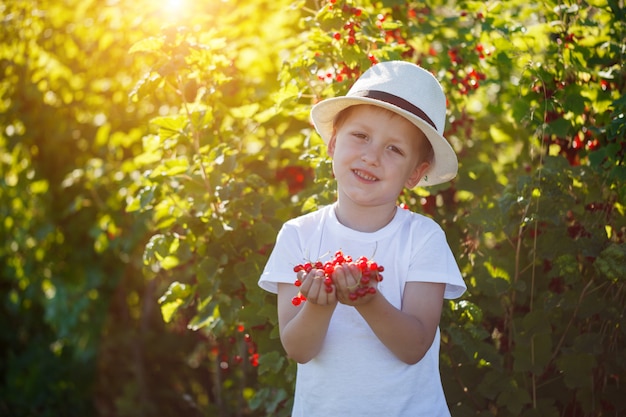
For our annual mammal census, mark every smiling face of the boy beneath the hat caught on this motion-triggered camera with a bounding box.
[328,105,429,205]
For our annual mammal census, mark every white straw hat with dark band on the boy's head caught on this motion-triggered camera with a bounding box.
[311,61,458,186]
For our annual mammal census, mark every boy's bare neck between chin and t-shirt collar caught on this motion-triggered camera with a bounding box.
[335,200,397,233]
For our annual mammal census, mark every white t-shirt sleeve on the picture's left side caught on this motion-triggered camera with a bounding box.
[258,223,304,294]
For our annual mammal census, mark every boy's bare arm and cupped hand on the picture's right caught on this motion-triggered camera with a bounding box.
[335,268,445,364]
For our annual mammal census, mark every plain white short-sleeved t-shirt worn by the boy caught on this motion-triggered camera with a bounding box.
[259,205,466,417]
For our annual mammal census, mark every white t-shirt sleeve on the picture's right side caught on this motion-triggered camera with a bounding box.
[407,227,467,299]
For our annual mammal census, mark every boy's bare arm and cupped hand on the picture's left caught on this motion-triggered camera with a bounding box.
[278,271,337,363]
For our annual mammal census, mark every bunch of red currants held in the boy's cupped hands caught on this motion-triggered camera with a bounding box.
[291,250,385,306]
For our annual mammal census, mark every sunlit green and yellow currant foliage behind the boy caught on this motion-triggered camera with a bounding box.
[0,0,626,417]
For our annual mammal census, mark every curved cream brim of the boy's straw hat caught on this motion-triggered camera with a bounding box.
[311,96,459,187]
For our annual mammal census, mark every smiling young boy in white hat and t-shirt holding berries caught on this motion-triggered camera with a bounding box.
[259,61,466,417]
